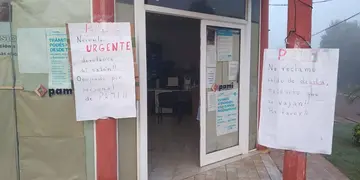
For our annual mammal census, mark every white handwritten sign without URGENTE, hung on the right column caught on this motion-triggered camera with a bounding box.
[258,49,339,154]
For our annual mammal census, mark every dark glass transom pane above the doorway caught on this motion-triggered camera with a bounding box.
[145,0,246,19]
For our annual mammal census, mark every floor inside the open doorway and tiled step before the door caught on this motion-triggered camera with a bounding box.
[149,117,281,180]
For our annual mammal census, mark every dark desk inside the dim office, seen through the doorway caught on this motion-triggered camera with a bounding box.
[148,89,192,114]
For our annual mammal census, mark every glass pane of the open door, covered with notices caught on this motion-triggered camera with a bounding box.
[206,26,241,153]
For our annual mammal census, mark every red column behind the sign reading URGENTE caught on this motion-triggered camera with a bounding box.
[92,0,118,180]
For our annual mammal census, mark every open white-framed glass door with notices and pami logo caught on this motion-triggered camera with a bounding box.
[200,20,249,166]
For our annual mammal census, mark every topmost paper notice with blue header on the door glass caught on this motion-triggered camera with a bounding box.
[216,29,234,61]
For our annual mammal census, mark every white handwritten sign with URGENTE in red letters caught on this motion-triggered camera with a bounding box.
[68,23,136,121]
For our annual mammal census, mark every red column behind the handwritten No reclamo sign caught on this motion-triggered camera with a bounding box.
[283,0,312,180]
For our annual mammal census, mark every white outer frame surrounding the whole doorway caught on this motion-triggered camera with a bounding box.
[134,0,251,180]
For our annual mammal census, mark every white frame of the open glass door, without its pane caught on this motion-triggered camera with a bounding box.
[200,20,250,166]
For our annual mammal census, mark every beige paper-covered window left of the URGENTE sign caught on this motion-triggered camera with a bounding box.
[9,0,90,180]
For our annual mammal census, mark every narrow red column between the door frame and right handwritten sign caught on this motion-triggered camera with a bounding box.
[256,0,269,151]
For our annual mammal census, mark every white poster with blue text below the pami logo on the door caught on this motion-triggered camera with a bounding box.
[216,89,238,136]
